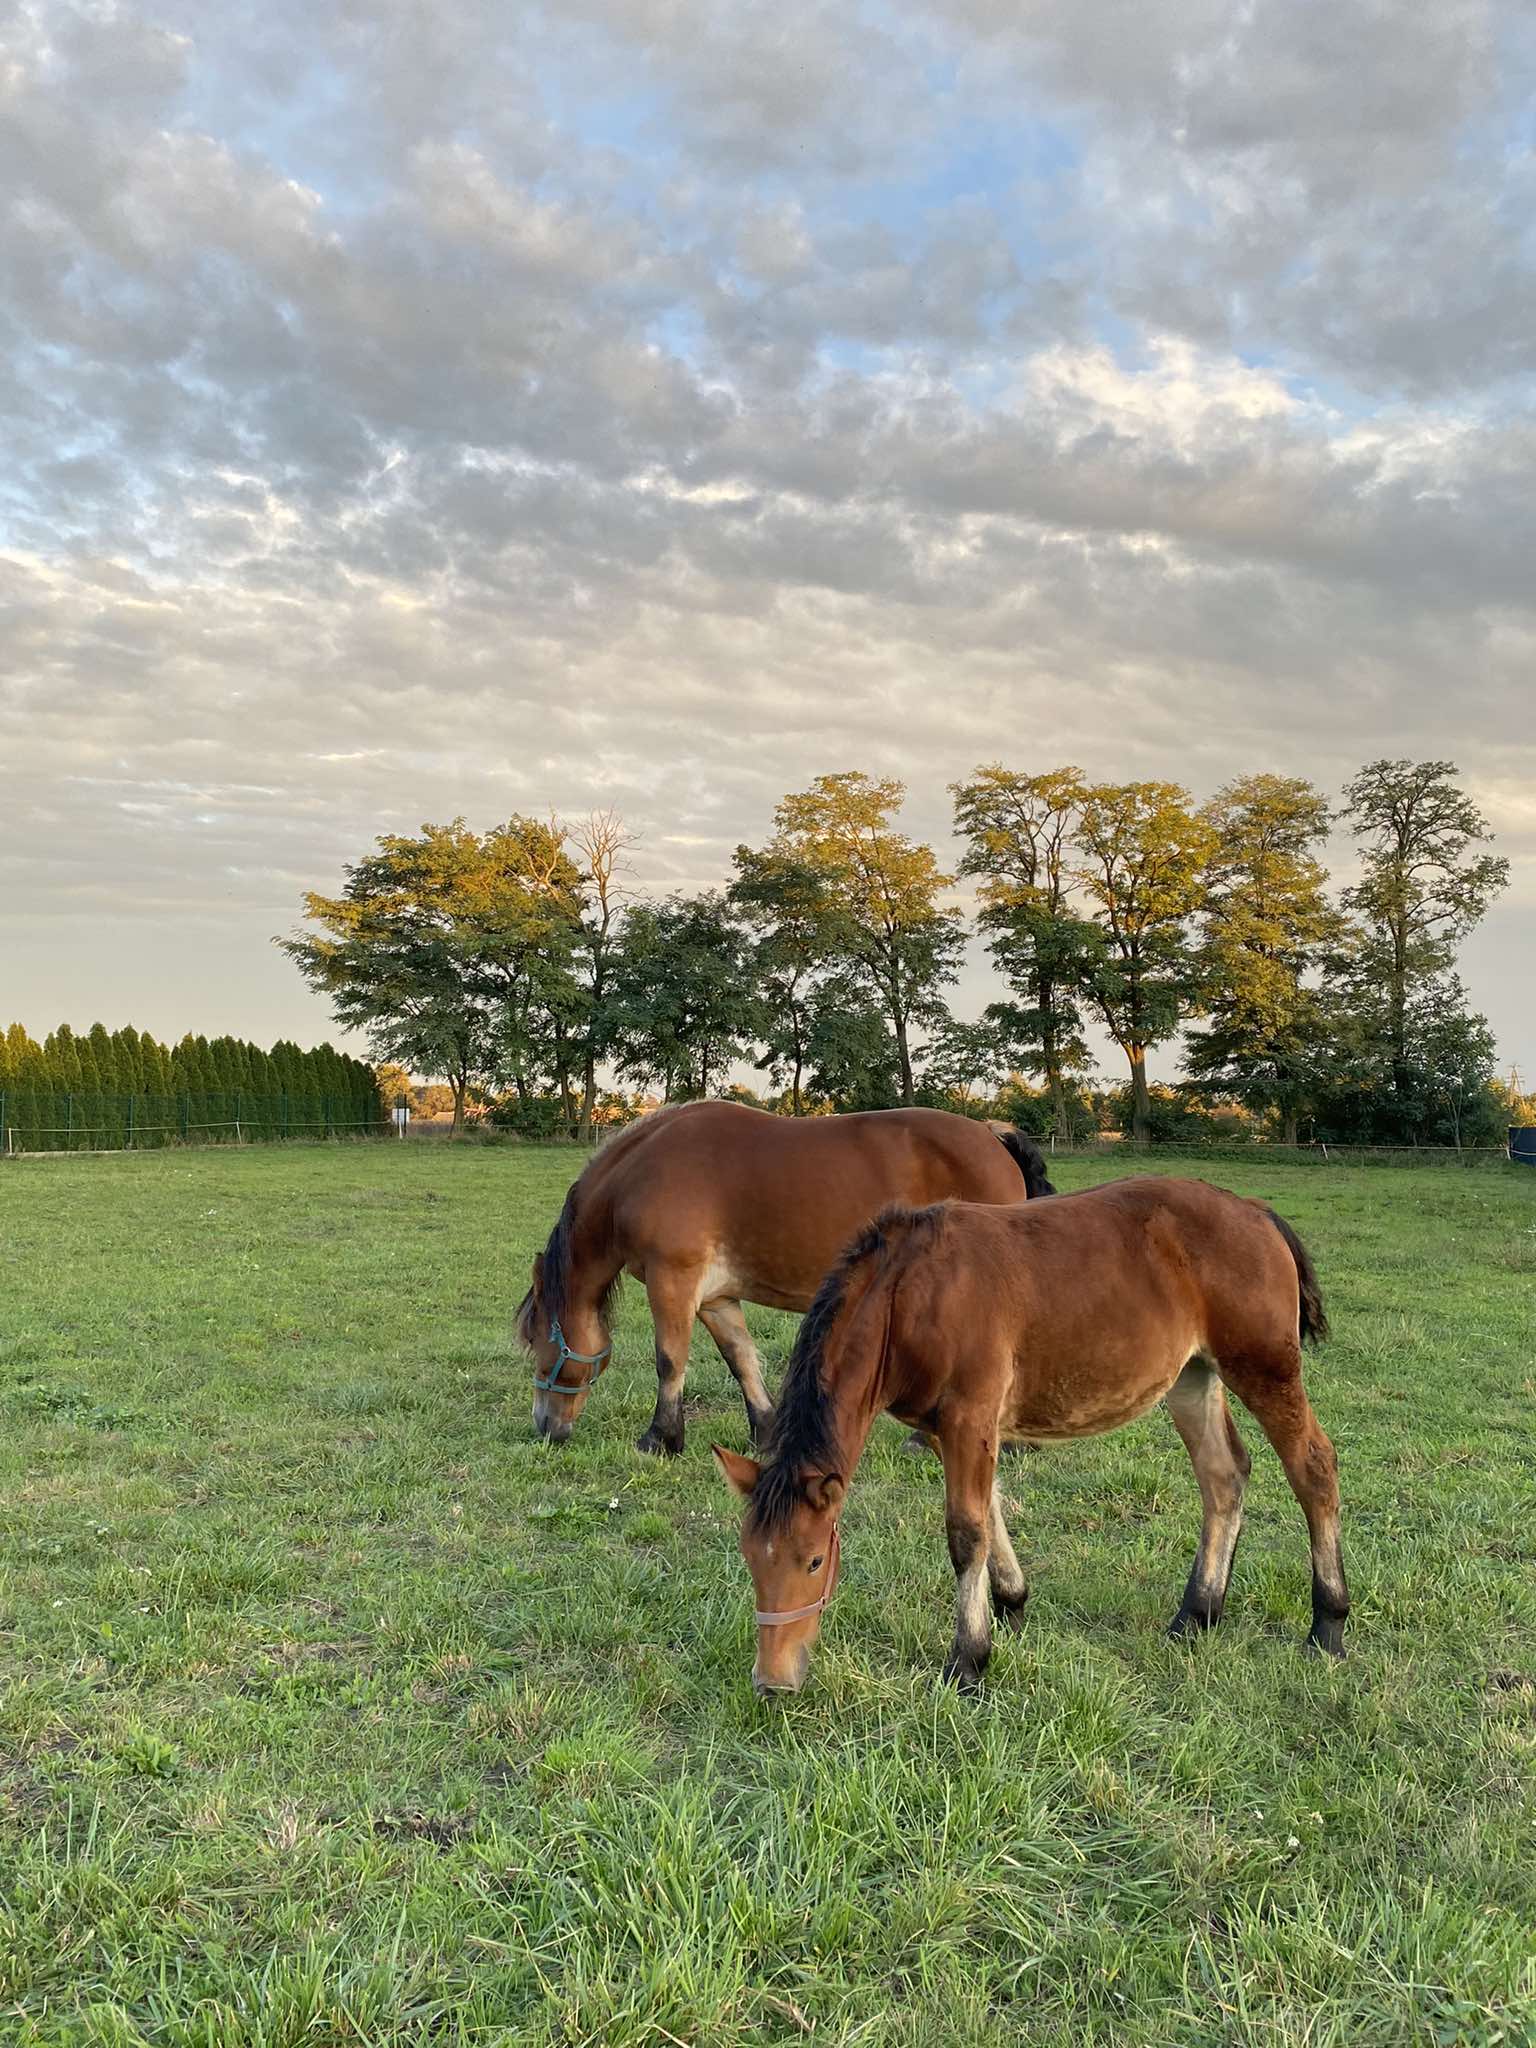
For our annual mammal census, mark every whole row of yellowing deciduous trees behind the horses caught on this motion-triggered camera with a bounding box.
[279,760,1507,1143]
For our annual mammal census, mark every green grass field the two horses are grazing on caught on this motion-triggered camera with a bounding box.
[0,1145,1536,2048]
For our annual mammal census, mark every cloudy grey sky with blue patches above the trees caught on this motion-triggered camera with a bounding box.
[0,0,1536,1079]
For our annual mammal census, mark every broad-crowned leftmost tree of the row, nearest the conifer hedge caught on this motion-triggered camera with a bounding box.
[279,817,580,1128]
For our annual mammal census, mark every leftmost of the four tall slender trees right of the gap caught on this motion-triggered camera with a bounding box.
[950,762,1090,1137]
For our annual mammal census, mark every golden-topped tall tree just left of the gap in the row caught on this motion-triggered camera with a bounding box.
[774,772,965,1102]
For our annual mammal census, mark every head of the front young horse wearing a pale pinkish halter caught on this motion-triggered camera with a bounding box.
[715,1444,848,1692]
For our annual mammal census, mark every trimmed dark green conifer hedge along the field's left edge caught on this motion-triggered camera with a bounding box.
[0,1024,385,1151]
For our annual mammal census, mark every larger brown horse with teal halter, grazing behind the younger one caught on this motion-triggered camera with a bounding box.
[516,1102,1055,1454]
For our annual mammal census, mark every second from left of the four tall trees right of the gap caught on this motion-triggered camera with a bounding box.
[1077,782,1217,1143]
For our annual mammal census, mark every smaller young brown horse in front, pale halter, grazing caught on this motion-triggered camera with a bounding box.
[715,1180,1350,1692]
